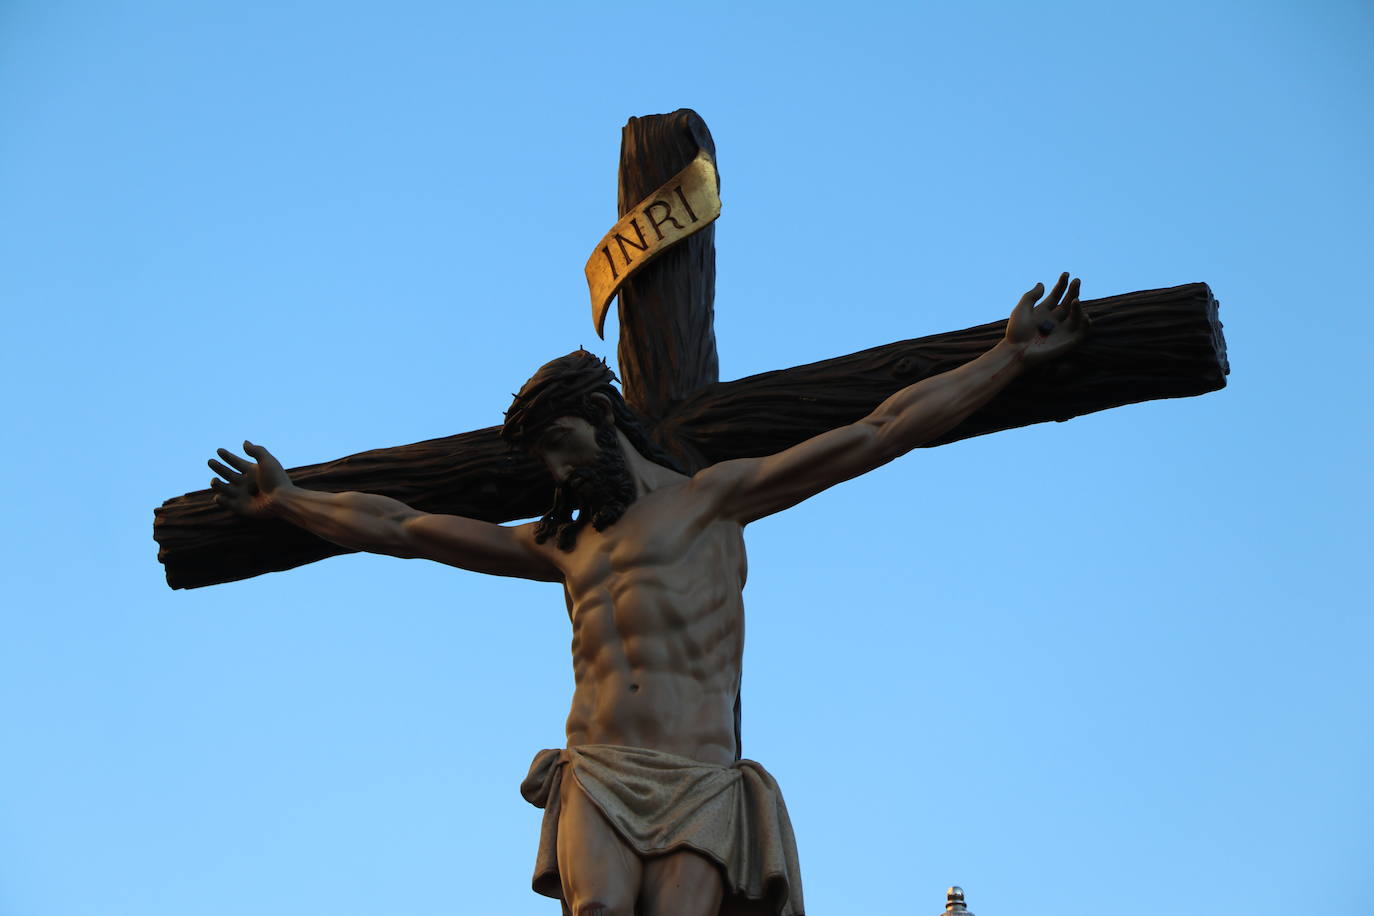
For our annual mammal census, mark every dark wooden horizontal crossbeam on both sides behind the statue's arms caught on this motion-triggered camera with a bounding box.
[154,283,1228,588]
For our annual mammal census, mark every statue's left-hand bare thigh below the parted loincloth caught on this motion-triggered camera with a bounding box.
[558,768,643,916]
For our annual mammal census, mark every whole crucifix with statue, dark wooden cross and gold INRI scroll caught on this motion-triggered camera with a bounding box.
[154,110,1228,916]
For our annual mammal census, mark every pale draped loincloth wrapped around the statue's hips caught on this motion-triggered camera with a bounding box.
[519,744,804,916]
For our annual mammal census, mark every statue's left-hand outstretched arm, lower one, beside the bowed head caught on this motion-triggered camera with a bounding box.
[209,442,562,582]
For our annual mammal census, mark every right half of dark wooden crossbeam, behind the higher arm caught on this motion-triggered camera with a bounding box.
[657,283,1230,464]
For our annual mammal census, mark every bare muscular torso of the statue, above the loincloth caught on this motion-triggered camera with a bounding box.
[544,481,746,765]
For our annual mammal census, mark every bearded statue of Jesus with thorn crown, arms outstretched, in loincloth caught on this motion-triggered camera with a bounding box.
[209,273,1087,916]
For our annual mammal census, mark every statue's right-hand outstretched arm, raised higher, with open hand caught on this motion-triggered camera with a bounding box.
[692,273,1087,523]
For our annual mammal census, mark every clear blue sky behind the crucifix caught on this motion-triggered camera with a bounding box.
[0,0,1374,916]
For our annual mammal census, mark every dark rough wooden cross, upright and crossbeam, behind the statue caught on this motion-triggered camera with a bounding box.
[153,108,1230,588]
